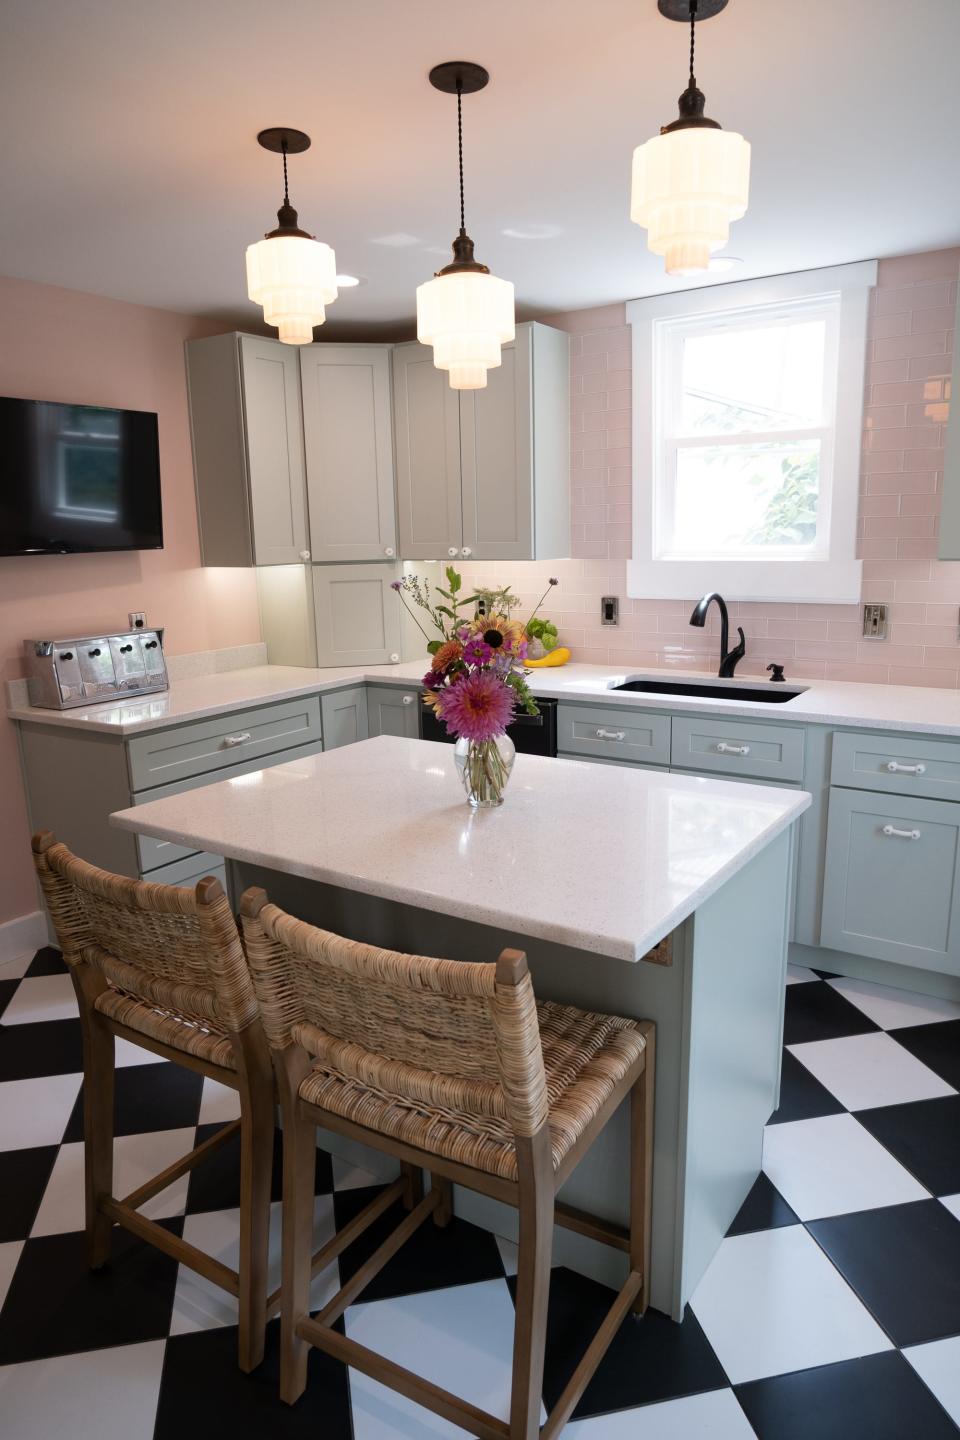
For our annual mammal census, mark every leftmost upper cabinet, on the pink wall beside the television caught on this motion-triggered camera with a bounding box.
[187,334,309,566]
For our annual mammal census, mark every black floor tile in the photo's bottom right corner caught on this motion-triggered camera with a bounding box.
[734,1351,960,1440]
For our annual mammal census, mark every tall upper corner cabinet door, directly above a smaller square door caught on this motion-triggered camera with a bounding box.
[299,344,397,560]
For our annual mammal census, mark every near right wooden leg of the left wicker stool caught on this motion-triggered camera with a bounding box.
[237,1034,273,1371]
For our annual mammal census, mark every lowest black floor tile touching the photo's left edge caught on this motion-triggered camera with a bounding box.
[0,1220,183,1365]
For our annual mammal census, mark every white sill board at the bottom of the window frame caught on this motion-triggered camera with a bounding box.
[626,560,862,605]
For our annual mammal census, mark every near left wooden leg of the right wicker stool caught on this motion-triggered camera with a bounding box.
[281,1106,317,1405]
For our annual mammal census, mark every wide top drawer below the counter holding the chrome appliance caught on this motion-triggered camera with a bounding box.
[127,696,321,791]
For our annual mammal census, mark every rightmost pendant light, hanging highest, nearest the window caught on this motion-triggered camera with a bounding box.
[630,0,750,275]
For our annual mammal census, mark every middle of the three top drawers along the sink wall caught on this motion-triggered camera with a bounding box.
[671,716,803,780]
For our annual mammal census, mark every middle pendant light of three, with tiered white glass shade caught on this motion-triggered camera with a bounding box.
[417,60,514,390]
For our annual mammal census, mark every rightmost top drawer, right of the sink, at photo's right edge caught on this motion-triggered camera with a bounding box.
[830,733,960,801]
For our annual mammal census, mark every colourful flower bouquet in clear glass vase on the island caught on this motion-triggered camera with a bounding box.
[393,566,557,809]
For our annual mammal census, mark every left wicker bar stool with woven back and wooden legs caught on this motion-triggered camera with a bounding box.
[33,831,279,1371]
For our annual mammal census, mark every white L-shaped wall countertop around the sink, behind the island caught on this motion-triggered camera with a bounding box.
[7,657,960,736]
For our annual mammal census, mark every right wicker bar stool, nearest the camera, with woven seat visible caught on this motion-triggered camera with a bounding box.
[240,890,655,1440]
